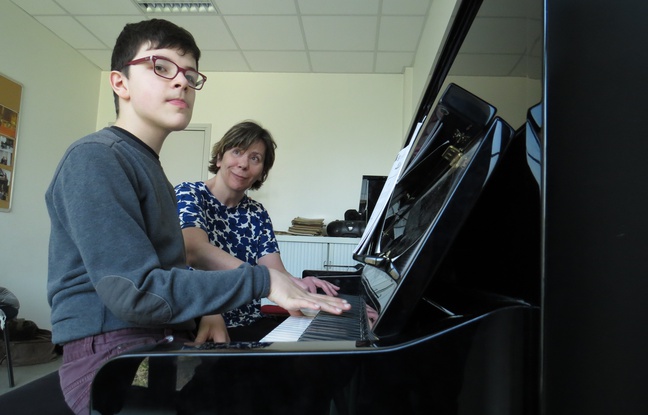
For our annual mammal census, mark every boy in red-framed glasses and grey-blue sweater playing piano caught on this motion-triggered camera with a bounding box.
[45,19,349,414]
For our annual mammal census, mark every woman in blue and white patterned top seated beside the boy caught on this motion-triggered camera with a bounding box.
[175,121,339,342]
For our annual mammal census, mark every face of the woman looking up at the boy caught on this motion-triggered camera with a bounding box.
[216,140,266,192]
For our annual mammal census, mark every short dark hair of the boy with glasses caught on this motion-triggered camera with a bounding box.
[110,19,200,115]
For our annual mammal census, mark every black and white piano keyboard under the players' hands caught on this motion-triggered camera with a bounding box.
[261,294,375,342]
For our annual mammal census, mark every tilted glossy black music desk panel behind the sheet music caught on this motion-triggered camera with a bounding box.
[374,84,496,272]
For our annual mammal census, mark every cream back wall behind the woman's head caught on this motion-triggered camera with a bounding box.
[97,72,403,230]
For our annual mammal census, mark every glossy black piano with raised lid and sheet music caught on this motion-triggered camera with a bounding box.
[91,0,542,415]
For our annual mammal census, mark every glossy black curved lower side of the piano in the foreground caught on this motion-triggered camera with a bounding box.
[93,306,537,415]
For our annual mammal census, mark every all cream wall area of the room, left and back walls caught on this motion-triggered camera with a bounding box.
[0,0,455,328]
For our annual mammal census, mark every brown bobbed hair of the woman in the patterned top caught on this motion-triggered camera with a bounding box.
[208,121,277,190]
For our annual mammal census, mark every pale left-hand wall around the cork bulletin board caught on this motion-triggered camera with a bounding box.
[0,0,101,328]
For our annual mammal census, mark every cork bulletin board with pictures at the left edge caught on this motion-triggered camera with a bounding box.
[0,74,22,212]
